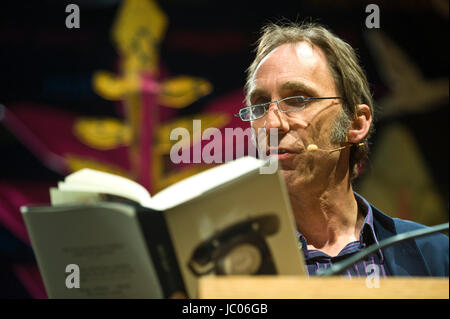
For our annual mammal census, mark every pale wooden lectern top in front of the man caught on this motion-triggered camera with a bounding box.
[198,276,449,299]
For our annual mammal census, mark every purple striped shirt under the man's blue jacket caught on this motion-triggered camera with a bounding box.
[297,193,388,278]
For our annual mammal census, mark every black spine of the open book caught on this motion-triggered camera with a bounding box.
[137,207,186,298]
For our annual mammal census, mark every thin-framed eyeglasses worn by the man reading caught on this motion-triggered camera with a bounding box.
[234,96,342,121]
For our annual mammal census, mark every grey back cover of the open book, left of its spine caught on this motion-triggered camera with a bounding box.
[22,203,163,299]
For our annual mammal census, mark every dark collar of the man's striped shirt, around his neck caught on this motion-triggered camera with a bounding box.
[297,192,384,262]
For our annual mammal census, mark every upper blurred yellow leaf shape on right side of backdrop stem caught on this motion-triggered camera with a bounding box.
[158,75,212,108]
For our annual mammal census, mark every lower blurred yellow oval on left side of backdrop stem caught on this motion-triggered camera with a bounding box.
[73,117,131,151]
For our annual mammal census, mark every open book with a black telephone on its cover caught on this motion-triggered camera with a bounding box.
[21,157,305,298]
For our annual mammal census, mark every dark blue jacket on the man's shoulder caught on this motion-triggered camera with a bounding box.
[371,205,449,277]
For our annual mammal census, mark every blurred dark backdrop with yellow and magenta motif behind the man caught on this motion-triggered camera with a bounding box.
[0,0,449,298]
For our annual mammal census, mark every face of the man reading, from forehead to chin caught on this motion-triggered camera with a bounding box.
[250,42,342,193]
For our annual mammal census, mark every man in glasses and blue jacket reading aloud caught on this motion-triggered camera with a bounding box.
[239,24,448,276]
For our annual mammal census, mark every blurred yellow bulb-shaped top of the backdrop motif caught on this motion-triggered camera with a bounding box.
[112,0,168,73]
